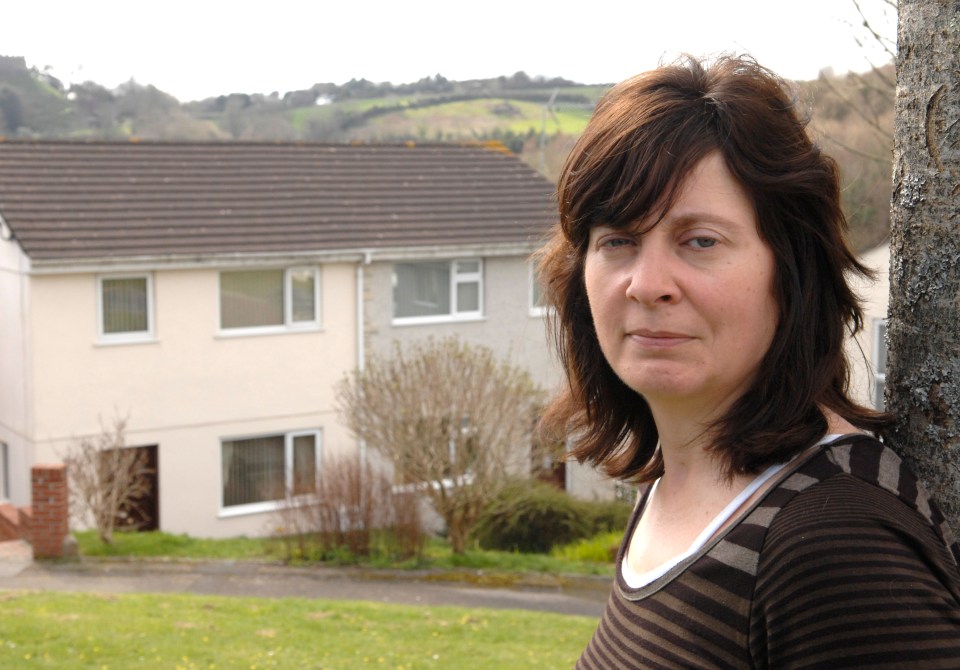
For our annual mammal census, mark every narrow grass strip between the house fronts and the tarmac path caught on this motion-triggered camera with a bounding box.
[74,531,613,576]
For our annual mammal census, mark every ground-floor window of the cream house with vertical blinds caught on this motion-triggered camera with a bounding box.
[221,431,320,511]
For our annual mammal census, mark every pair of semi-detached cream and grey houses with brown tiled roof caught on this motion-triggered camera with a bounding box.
[0,141,609,537]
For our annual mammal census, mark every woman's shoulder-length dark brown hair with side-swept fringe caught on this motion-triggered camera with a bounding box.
[538,57,890,481]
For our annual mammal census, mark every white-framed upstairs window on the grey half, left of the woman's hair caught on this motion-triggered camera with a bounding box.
[393,259,483,323]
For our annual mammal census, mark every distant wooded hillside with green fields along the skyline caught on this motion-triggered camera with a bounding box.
[0,57,894,248]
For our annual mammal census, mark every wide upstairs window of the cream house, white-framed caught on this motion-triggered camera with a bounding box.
[220,268,320,330]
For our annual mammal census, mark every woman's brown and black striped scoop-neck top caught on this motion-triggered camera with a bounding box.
[577,435,960,670]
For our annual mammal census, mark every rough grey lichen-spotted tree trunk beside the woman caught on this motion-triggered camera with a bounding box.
[886,0,960,529]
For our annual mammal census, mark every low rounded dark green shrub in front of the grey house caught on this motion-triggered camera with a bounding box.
[474,480,591,553]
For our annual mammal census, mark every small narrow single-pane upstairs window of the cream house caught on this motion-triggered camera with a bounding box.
[97,275,153,342]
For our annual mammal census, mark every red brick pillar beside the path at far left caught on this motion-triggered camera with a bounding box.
[24,463,70,558]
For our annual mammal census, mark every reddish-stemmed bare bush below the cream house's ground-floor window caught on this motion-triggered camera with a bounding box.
[274,456,424,560]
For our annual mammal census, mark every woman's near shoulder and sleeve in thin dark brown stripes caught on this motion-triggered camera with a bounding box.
[751,436,960,667]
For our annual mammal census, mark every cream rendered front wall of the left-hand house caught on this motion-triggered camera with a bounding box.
[28,263,357,537]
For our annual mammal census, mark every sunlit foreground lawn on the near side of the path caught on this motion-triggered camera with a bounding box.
[0,592,596,670]
